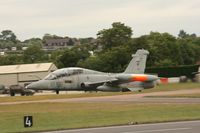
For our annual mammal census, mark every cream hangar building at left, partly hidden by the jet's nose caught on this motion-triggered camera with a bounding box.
[0,63,57,86]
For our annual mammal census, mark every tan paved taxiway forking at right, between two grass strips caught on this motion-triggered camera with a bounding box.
[0,89,200,105]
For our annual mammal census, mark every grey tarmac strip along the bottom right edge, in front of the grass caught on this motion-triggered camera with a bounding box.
[40,121,200,133]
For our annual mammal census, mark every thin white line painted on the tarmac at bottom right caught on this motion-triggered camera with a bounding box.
[123,128,192,133]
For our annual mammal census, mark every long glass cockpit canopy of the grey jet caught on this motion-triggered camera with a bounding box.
[44,68,83,80]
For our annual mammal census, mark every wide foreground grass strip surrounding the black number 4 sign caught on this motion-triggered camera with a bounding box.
[0,103,200,132]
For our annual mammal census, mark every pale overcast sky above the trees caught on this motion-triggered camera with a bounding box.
[0,0,200,40]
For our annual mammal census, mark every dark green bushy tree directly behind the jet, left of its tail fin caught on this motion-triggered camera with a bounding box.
[78,46,131,72]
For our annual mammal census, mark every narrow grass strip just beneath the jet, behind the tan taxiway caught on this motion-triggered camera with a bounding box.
[0,82,200,103]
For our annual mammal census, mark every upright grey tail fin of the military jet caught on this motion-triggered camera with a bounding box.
[124,49,149,74]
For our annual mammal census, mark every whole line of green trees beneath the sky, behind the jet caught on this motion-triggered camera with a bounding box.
[0,22,200,72]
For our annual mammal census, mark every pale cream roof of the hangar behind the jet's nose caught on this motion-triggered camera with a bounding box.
[0,63,57,74]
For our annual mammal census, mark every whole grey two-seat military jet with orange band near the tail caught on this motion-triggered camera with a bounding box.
[26,49,158,94]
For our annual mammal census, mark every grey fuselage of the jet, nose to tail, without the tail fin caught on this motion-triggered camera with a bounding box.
[27,67,157,91]
